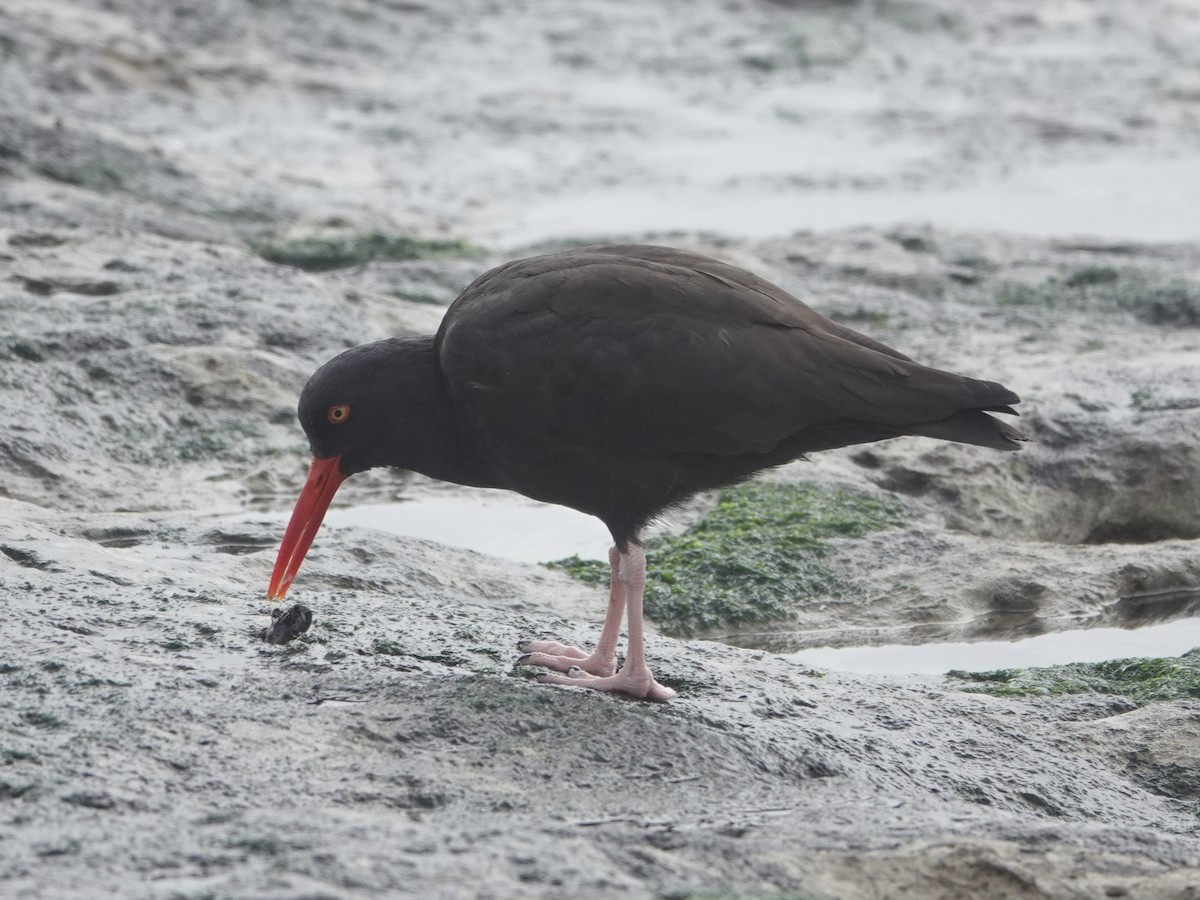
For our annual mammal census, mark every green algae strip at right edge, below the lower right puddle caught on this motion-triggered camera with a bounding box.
[947,648,1200,704]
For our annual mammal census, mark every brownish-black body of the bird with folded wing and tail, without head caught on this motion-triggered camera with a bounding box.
[436,245,1021,542]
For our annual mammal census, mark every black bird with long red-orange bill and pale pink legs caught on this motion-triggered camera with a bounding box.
[268,245,1027,701]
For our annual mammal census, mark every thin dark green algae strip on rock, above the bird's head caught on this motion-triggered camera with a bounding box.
[252,232,481,272]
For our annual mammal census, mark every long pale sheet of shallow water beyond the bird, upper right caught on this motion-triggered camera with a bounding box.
[499,156,1200,244]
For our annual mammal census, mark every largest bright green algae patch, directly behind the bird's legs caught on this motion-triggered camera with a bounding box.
[548,481,906,636]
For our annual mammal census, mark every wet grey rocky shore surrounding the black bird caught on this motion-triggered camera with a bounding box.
[0,0,1200,900]
